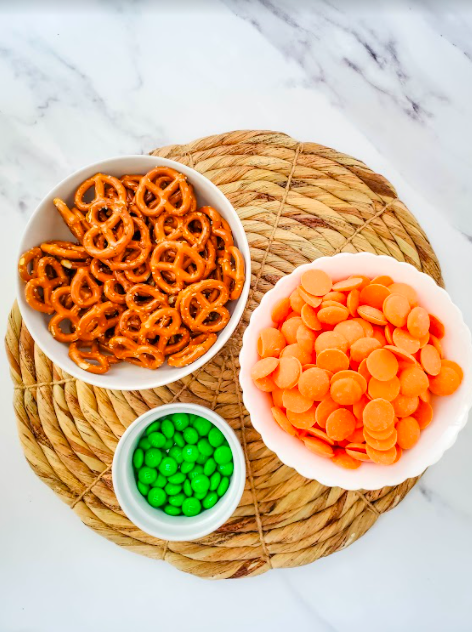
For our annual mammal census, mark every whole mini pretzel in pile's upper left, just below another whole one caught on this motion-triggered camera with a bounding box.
[84,200,134,259]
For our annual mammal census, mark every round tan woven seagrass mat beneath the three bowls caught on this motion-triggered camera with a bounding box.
[6,130,442,579]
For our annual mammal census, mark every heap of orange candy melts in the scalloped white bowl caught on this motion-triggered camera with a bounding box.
[251,269,463,469]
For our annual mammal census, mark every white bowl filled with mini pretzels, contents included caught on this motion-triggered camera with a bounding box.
[18,156,251,390]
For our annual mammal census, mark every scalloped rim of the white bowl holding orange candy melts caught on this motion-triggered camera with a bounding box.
[239,252,472,490]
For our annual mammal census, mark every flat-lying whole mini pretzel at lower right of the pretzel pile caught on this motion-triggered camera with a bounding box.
[179,279,230,333]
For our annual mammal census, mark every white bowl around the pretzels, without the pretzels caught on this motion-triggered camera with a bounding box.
[18,156,251,390]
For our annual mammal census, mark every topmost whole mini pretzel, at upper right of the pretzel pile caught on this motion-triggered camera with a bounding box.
[136,167,195,217]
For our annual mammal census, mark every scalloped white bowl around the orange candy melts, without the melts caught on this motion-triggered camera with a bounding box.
[239,253,472,489]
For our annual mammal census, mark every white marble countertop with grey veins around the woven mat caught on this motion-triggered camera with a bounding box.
[0,0,472,632]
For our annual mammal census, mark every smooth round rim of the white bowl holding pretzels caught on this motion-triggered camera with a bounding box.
[16,154,251,391]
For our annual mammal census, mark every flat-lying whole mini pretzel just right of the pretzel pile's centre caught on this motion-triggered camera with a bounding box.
[151,241,205,294]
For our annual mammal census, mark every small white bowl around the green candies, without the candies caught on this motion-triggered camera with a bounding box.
[112,404,246,542]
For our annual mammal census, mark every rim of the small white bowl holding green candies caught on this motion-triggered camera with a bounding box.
[112,402,246,542]
